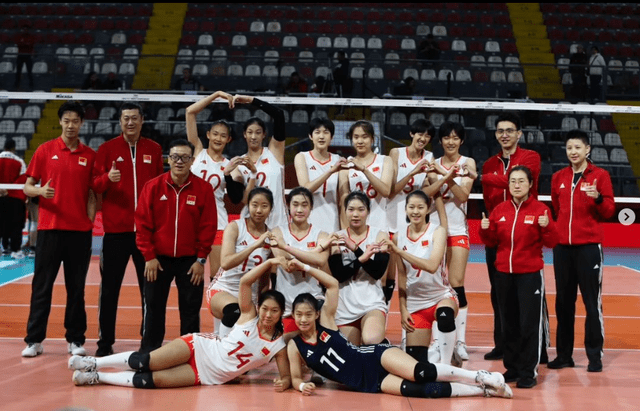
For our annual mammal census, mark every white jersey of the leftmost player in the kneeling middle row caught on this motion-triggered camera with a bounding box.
[209,218,271,301]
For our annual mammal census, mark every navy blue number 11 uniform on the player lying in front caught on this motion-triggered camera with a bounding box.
[293,325,393,392]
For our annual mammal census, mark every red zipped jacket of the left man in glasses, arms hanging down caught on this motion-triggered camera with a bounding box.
[135,172,218,261]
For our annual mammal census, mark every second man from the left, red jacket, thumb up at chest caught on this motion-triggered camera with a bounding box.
[94,103,163,357]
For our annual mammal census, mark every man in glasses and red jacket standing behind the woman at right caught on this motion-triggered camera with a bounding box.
[482,113,546,360]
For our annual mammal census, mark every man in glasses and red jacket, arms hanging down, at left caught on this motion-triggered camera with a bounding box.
[136,140,217,352]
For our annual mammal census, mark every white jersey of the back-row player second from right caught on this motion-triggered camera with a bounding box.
[387,147,433,233]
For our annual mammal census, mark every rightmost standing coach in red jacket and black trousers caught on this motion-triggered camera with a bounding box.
[547,130,615,372]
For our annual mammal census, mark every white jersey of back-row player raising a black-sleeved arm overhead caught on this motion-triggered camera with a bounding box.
[238,147,289,232]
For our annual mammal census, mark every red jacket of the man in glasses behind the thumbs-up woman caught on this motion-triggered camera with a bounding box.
[482,147,541,213]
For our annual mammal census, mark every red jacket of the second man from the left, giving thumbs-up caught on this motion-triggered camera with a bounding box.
[94,134,164,233]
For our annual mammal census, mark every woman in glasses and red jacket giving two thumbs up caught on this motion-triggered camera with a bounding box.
[480,166,557,388]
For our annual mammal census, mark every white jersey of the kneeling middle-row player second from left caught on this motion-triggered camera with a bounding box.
[276,224,324,317]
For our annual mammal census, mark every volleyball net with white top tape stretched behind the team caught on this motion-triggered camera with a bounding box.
[0,91,640,247]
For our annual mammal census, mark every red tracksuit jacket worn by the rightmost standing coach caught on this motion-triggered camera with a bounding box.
[551,163,616,245]
